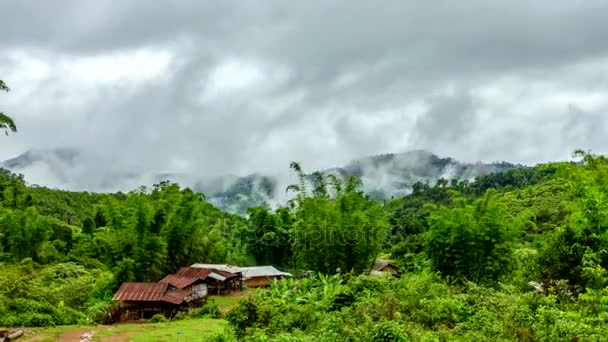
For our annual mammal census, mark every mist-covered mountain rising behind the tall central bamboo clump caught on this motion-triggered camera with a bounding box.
[195,150,522,214]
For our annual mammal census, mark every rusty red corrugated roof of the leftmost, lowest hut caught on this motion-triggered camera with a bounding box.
[112,283,188,304]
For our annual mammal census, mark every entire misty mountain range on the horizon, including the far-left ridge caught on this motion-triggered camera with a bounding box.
[0,149,520,214]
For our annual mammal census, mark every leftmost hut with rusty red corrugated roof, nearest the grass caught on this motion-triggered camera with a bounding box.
[112,283,190,321]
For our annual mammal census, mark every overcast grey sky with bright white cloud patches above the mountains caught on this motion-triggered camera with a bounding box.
[0,0,608,180]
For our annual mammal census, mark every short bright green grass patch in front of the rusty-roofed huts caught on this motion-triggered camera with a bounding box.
[93,318,226,342]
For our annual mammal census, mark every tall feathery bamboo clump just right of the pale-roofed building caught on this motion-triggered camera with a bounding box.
[288,163,390,274]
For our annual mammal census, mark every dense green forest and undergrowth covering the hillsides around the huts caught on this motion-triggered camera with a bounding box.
[0,152,608,341]
